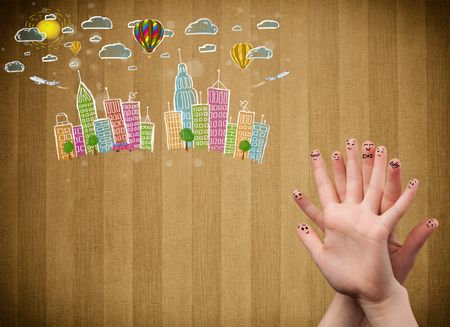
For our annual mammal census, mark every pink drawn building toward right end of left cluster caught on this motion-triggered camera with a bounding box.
[122,92,141,149]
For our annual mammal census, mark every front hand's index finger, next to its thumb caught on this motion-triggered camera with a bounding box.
[311,150,338,208]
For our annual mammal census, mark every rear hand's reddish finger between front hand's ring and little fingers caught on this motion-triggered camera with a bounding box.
[380,159,402,214]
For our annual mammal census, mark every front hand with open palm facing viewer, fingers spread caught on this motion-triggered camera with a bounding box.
[298,139,418,302]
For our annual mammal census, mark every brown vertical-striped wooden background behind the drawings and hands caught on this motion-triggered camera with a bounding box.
[0,0,450,326]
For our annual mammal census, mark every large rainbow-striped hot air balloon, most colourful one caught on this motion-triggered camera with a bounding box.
[134,19,164,54]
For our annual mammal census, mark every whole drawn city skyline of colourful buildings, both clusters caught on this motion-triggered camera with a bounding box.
[54,54,270,163]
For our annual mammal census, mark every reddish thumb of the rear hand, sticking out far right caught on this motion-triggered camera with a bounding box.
[401,218,439,267]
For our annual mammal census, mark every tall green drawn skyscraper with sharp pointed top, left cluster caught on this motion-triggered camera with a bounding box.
[77,71,97,154]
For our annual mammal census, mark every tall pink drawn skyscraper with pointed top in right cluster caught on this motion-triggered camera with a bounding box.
[208,69,230,152]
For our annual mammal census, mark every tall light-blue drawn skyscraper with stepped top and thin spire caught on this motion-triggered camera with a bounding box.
[173,49,197,146]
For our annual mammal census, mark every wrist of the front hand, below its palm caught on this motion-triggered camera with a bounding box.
[358,283,418,327]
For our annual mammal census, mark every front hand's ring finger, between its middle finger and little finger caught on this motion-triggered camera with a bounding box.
[364,146,387,214]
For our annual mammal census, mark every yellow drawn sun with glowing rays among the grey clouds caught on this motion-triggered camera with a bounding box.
[25,8,71,49]
